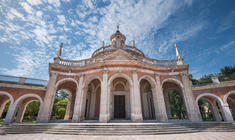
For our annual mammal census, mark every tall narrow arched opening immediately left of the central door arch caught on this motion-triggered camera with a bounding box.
[84,79,101,120]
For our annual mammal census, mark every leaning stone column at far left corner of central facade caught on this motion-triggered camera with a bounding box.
[37,73,57,122]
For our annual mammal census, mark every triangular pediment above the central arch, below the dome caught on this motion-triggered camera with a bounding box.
[104,49,136,60]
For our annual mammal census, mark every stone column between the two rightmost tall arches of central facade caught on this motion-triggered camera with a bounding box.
[153,75,168,122]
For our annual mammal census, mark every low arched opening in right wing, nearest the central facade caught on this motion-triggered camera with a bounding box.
[196,93,224,121]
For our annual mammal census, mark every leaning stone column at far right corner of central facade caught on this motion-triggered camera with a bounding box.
[181,74,201,121]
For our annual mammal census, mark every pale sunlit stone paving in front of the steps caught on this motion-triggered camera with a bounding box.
[0,132,235,140]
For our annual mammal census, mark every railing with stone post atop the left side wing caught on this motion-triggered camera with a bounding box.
[0,75,47,86]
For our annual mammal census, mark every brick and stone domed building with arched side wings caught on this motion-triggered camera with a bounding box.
[0,30,235,123]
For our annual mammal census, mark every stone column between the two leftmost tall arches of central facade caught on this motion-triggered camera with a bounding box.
[72,75,83,122]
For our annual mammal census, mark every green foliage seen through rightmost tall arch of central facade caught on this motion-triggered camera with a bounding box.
[168,90,187,119]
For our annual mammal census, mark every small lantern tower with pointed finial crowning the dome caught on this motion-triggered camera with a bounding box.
[110,25,126,48]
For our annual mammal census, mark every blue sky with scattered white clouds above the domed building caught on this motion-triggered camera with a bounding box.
[0,0,235,80]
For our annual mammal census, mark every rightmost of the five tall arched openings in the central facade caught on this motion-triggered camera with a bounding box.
[162,81,188,120]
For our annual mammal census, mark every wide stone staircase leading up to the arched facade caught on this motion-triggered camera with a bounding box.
[2,122,235,135]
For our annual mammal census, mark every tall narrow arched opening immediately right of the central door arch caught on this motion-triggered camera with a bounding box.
[140,79,156,120]
